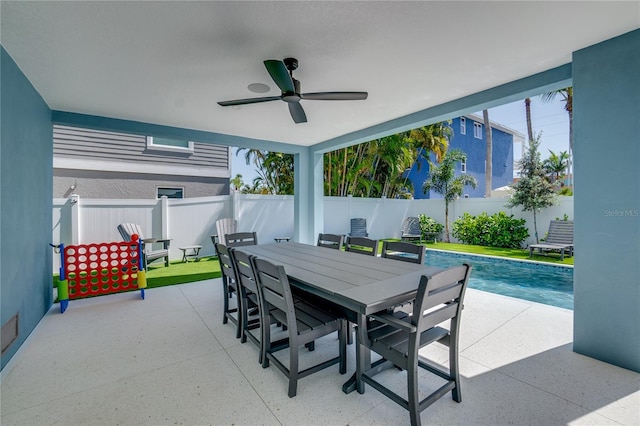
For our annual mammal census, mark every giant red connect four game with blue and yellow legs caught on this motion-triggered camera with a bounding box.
[56,235,147,313]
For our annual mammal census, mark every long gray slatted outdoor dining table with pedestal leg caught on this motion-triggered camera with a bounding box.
[239,242,442,393]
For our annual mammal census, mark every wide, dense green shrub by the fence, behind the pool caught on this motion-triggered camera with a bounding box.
[452,212,529,248]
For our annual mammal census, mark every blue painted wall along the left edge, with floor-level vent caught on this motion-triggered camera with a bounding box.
[0,46,53,368]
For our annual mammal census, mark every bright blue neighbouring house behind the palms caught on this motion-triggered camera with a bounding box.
[409,117,513,199]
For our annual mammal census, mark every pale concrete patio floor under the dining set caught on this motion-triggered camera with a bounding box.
[0,279,640,425]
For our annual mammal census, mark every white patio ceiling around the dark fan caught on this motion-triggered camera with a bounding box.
[0,0,640,145]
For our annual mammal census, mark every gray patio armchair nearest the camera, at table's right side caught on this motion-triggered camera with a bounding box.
[362,264,471,426]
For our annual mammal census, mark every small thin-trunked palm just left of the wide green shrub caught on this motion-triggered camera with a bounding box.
[422,149,478,242]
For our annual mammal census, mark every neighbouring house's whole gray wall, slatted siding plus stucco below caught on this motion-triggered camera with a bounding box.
[53,125,229,199]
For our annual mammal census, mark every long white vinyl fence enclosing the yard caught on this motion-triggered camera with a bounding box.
[52,193,573,272]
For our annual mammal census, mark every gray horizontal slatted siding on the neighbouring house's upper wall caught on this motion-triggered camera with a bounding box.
[53,125,229,170]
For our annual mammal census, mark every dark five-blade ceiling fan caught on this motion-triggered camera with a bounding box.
[218,58,368,123]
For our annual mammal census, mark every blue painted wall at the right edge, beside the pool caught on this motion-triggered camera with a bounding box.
[573,30,640,371]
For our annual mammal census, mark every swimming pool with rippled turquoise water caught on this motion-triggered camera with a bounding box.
[425,250,573,309]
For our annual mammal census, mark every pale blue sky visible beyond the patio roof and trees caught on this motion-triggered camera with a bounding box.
[231,95,569,183]
